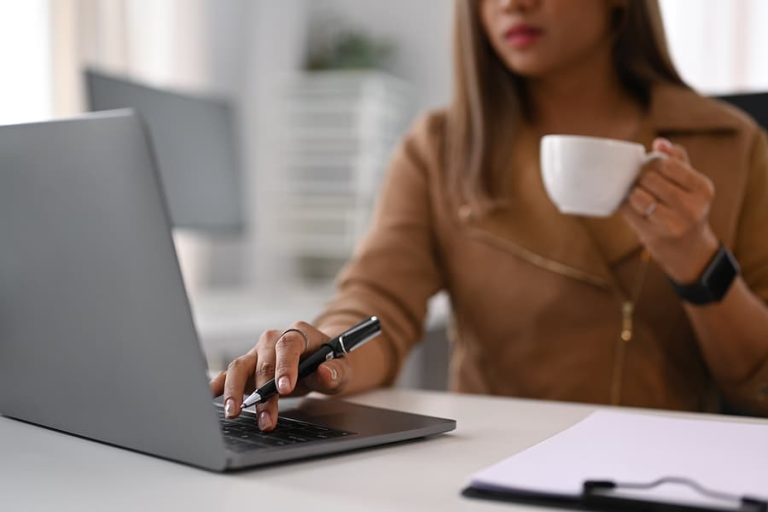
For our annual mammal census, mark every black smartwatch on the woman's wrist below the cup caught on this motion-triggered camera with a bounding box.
[670,244,739,306]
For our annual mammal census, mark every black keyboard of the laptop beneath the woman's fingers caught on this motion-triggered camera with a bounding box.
[216,407,352,452]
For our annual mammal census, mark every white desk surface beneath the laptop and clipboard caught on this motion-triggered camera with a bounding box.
[0,390,768,512]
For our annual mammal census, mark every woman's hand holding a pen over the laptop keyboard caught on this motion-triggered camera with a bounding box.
[210,322,351,431]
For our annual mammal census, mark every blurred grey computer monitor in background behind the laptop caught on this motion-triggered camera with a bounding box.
[85,69,244,232]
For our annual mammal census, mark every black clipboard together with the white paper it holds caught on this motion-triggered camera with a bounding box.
[462,410,768,512]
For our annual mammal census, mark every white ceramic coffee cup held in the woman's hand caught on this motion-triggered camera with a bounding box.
[541,135,666,217]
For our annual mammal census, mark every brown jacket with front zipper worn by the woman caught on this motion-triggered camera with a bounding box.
[317,86,768,414]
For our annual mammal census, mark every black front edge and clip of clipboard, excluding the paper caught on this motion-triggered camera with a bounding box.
[461,477,768,512]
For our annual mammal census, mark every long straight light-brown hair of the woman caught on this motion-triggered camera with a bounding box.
[447,0,687,210]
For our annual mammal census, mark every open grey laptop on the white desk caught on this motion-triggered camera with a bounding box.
[0,111,456,471]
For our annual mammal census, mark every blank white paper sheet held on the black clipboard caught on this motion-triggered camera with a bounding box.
[472,411,768,505]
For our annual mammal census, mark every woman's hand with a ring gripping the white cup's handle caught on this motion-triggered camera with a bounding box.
[620,139,719,283]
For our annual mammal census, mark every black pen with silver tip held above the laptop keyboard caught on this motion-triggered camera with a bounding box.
[241,316,381,409]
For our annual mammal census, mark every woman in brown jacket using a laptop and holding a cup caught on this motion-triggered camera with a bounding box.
[211,0,768,430]
